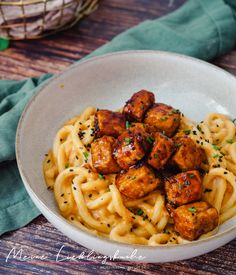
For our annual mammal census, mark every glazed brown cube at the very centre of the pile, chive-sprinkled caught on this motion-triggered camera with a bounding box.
[113,123,148,170]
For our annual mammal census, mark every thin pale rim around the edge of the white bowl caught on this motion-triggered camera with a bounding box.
[15,50,236,250]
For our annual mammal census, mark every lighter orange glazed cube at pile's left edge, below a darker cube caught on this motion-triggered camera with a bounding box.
[91,136,120,174]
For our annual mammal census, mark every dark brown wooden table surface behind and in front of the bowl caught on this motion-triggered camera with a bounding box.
[0,0,236,274]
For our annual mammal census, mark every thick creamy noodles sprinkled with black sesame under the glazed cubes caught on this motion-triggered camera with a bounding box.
[43,107,236,245]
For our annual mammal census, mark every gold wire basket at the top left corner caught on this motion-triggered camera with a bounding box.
[0,0,98,40]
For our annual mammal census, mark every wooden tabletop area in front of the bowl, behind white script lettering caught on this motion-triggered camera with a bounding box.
[0,216,236,275]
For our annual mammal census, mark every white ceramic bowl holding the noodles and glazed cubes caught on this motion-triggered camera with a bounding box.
[16,51,236,262]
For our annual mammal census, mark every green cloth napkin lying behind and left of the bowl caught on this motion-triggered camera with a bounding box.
[0,0,236,237]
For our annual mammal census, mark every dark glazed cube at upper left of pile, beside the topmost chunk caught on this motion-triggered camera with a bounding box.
[95,110,125,137]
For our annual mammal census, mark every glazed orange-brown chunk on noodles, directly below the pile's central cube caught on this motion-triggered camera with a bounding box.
[116,165,161,199]
